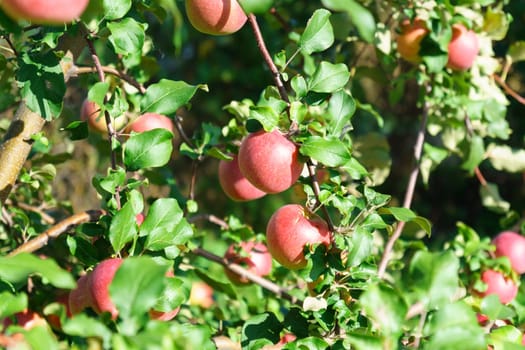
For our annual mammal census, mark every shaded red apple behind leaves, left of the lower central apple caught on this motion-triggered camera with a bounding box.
[224,241,272,284]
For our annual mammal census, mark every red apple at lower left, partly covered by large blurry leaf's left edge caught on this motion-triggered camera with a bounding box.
[89,258,123,320]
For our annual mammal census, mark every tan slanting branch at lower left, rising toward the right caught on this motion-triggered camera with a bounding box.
[8,210,104,256]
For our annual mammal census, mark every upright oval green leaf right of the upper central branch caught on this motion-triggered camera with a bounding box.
[299,9,334,55]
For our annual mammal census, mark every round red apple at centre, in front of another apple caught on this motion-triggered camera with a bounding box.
[239,130,304,193]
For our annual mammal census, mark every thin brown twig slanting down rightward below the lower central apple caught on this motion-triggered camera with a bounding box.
[192,248,302,306]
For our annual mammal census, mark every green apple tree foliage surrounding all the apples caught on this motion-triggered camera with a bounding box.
[0,0,525,349]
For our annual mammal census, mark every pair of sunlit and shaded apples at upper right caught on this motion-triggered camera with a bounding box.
[396,18,479,71]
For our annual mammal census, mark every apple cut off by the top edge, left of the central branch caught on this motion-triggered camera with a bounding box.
[186,0,248,35]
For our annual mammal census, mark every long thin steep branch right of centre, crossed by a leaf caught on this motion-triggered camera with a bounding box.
[377,85,430,278]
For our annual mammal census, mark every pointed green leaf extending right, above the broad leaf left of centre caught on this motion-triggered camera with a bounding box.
[140,79,208,115]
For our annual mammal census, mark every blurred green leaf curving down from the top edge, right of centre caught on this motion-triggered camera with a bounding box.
[321,0,376,43]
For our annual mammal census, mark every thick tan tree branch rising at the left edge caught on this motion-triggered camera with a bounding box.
[0,102,45,206]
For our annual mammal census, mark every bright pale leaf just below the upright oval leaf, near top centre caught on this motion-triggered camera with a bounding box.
[308,61,350,93]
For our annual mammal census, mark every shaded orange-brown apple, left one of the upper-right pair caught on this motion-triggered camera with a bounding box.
[396,18,428,63]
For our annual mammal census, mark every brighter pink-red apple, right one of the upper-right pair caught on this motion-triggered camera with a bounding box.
[447,23,479,71]
